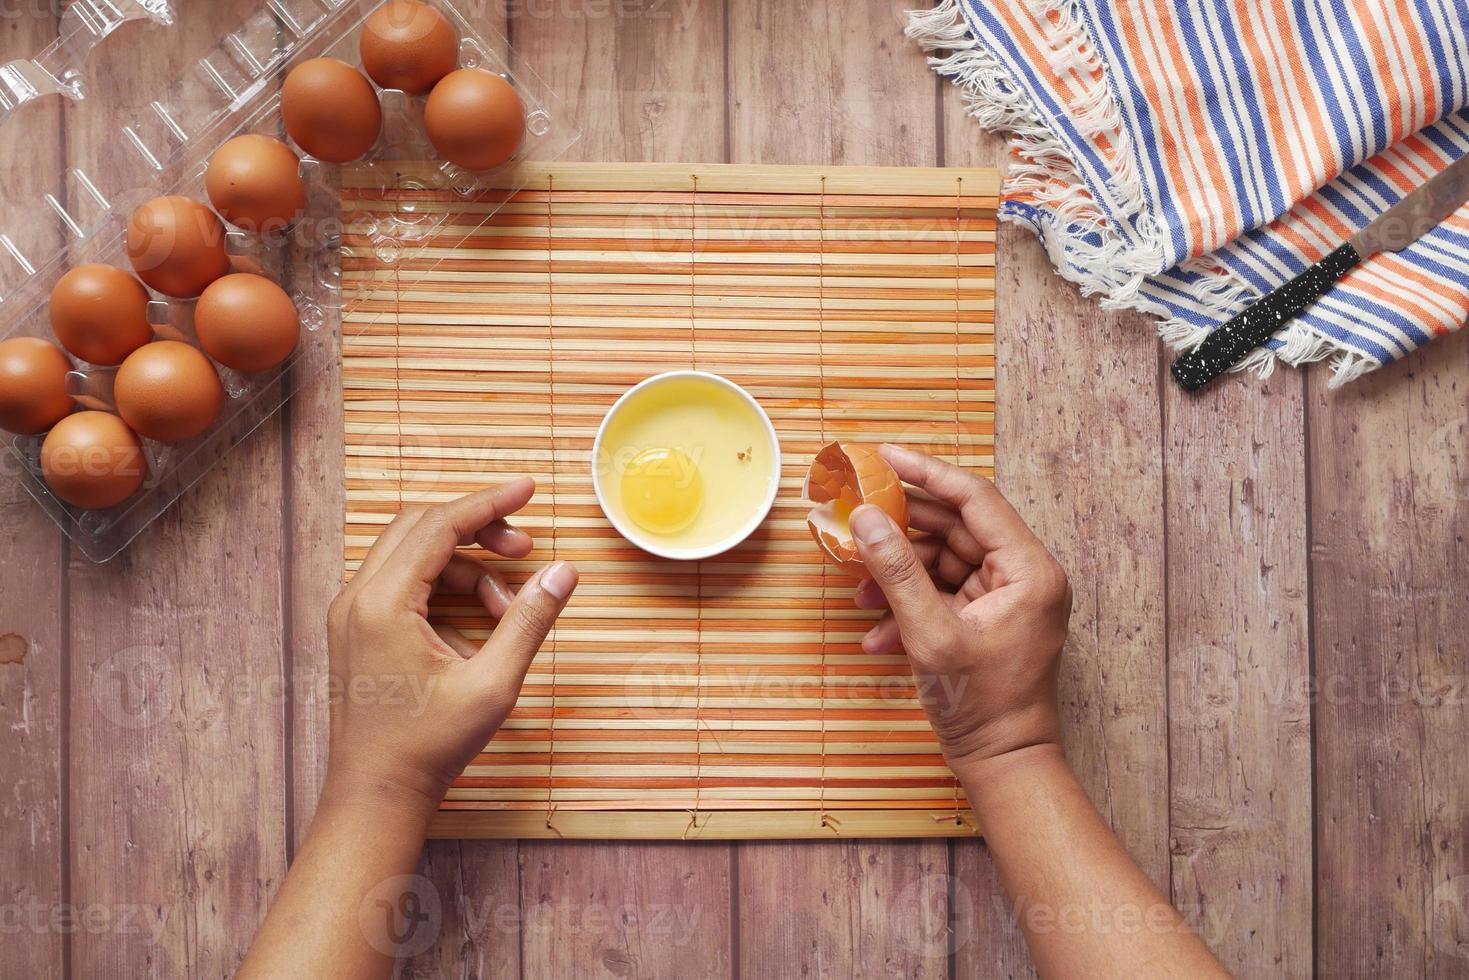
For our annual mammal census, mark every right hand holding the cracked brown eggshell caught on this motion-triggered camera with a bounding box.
[852,445,1071,765]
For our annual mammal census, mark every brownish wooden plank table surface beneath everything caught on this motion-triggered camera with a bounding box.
[0,0,1469,977]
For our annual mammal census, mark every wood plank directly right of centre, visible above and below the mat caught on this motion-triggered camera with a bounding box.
[729,0,949,976]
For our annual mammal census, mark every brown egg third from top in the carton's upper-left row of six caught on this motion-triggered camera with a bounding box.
[204,135,306,234]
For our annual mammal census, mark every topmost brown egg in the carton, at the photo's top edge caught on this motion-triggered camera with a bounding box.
[360,0,458,96]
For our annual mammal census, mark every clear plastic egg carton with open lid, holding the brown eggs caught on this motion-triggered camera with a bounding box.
[0,0,580,561]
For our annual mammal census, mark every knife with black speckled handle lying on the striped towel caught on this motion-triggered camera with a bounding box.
[1172,156,1469,391]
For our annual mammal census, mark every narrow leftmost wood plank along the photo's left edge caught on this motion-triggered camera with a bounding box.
[0,13,71,977]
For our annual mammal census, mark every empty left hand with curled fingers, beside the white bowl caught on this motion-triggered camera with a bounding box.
[328,476,577,810]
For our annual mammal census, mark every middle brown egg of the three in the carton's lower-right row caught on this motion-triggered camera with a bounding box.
[112,341,225,442]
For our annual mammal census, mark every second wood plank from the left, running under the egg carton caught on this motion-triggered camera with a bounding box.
[68,4,286,976]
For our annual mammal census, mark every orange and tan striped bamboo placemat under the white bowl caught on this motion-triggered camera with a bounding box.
[342,163,999,839]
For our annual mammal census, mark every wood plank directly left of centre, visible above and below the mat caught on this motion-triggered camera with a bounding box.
[508,0,733,977]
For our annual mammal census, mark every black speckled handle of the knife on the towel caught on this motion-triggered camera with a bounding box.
[1172,241,1362,391]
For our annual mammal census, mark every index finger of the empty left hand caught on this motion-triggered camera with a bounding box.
[373,476,536,597]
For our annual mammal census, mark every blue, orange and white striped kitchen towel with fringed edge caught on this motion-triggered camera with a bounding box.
[908,0,1469,386]
